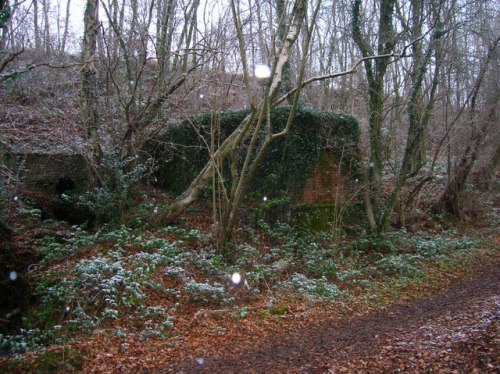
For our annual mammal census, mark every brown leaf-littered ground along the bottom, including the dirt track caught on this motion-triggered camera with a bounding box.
[67,241,500,373]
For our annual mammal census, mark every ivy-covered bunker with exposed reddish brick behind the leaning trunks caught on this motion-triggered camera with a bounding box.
[148,106,361,228]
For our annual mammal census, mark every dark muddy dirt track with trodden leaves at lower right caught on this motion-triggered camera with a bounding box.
[162,269,500,373]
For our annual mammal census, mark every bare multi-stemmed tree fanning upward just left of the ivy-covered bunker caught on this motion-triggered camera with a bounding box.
[101,1,208,157]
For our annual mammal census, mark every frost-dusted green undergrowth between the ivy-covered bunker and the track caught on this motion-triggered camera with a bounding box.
[0,187,494,357]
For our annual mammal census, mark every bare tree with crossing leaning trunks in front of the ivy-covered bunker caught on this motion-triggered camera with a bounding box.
[160,0,319,245]
